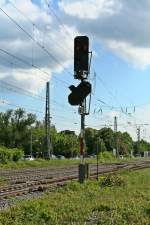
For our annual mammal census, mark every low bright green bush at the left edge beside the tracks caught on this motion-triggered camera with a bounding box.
[0,147,23,164]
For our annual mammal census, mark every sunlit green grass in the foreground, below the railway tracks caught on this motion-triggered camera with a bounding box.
[0,169,150,225]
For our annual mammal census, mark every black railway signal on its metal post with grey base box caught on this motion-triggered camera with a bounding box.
[68,36,92,183]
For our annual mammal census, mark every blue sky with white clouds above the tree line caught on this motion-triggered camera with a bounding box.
[0,0,150,141]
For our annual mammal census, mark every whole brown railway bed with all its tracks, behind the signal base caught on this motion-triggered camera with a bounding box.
[0,160,150,200]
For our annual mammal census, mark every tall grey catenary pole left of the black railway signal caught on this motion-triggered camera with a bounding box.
[44,82,51,159]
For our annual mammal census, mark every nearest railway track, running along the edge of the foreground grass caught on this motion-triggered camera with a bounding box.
[0,161,150,199]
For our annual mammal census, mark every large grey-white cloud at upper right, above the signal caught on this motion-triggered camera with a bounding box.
[59,0,150,69]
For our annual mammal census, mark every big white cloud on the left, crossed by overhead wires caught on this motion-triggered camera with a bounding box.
[0,0,77,91]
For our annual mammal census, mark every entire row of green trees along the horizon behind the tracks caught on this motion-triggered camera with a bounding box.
[0,108,150,157]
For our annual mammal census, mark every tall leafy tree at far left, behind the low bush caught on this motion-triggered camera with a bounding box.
[0,108,36,148]
